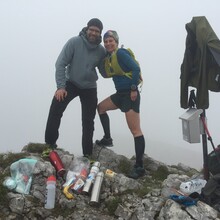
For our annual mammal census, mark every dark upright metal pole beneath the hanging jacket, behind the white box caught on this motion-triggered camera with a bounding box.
[201,109,209,181]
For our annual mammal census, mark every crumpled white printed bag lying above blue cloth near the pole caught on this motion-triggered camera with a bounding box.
[180,179,207,194]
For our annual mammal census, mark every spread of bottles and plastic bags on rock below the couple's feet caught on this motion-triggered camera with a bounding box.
[3,150,116,209]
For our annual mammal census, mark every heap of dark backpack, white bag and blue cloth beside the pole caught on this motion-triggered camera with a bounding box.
[170,145,220,211]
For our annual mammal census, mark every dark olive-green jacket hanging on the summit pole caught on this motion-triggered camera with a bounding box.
[180,16,220,109]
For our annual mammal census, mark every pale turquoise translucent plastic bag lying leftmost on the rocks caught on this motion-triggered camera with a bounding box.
[3,158,37,194]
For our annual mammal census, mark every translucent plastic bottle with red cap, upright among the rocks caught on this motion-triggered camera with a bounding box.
[44,175,56,209]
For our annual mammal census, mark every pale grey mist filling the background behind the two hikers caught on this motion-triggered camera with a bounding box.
[0,0,220,168]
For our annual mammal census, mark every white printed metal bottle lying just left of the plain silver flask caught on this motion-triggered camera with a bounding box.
[82,161,100,194]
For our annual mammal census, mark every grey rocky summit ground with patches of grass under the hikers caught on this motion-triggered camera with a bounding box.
[0,143,220,220]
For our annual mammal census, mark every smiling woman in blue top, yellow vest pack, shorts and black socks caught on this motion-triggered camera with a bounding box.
[96,30,145,179]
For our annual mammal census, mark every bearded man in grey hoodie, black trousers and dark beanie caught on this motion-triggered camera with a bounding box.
[45,18,105,157]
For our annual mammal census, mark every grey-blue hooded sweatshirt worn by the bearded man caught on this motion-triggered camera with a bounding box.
[55,28,105,89]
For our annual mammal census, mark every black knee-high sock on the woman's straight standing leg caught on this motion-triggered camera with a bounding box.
[134,135,145,167]
